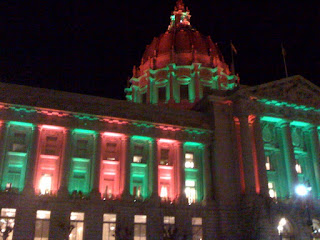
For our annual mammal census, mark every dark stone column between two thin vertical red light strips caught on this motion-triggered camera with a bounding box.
[239,116,256,194]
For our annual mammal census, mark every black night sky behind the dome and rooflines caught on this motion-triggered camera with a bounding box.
[0,0,320,99]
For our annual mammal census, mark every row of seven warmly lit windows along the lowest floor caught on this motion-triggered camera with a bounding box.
[0,208,203,240]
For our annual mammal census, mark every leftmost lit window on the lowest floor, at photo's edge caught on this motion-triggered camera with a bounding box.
[0,208,16,240]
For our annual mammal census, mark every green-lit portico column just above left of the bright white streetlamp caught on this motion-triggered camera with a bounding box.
[280,122,298,197]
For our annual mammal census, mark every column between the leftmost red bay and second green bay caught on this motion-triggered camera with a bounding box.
[58,129,72,197]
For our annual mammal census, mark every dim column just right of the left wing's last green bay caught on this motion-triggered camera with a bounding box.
[204,144,213,203]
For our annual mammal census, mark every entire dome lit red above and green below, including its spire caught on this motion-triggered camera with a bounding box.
[125,0,239,109]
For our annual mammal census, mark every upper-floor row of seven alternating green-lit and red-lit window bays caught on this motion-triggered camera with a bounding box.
[1,122,204,203]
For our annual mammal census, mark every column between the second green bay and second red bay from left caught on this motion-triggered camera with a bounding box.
[90,133,102,199]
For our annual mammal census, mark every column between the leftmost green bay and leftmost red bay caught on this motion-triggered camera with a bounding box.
[23,126,40,195]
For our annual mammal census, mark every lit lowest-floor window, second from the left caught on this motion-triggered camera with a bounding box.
[34,210,51,240]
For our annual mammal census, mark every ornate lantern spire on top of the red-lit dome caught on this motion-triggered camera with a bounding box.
[168,0,191,30]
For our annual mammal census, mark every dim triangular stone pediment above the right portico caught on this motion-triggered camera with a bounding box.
[240,76,320,108]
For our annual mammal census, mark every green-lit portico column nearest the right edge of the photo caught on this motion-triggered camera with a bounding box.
[308,126,320,199]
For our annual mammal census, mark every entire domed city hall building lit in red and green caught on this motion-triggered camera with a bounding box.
[0,0,320,240]
